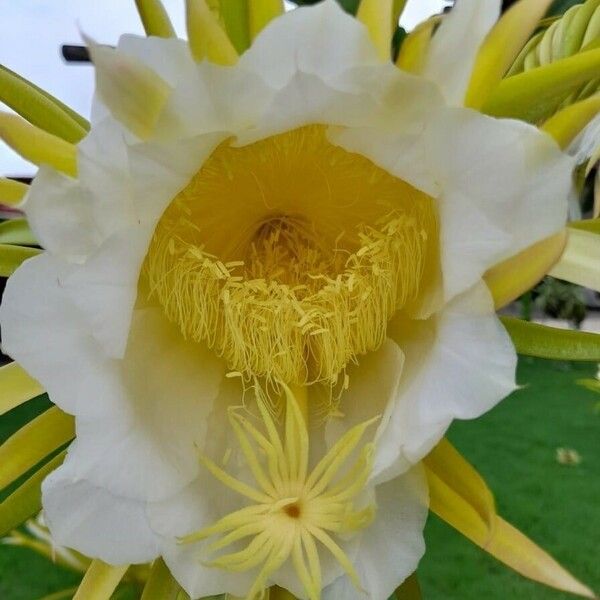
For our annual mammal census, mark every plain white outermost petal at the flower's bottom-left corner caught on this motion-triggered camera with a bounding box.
[42,457,159,565]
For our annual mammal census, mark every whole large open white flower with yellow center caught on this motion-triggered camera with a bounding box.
[0,0,572,600]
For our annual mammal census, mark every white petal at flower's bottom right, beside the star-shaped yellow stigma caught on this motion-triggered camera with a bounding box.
[323,468,428,600]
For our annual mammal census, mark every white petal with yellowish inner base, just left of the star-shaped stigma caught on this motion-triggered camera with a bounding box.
[67,309,227,500]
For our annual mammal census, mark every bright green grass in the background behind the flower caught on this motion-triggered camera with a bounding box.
[0,359,600,600]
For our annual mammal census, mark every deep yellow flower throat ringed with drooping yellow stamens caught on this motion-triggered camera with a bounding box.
[146,125,437,396]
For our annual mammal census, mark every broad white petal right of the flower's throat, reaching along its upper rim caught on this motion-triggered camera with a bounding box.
[330,108,574,301]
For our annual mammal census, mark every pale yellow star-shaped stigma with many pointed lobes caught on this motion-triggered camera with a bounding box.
[180,386,377,600]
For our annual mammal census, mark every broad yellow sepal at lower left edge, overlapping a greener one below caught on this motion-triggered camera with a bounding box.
[0,406,75,489]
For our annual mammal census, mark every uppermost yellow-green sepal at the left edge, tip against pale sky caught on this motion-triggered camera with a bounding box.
[0,65,90,144]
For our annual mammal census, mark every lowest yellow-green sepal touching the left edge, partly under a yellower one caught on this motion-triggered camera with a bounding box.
[0,451,66,537]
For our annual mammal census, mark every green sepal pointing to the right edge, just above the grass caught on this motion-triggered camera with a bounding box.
[500,317,600,362]
